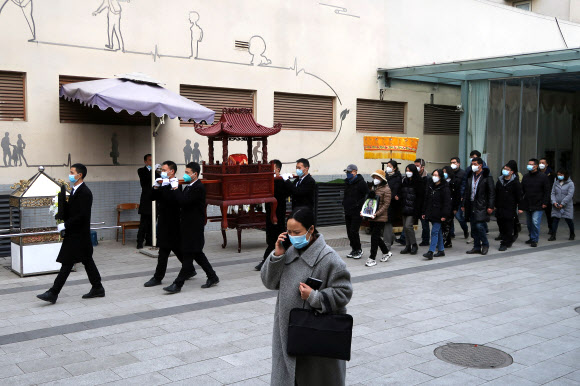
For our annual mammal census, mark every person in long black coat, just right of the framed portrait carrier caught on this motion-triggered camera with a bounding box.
[395,164,425,255]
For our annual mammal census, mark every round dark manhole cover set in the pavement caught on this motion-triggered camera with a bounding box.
[433,343,514,369]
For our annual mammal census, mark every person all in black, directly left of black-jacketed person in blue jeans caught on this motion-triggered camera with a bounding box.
[495,160,522,251]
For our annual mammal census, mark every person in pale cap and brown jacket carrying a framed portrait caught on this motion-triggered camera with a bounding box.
[361,170,393,267]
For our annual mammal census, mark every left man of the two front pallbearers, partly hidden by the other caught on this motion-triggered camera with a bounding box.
[144,161,196,287]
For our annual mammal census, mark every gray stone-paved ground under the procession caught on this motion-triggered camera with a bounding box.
[0,219,580,385]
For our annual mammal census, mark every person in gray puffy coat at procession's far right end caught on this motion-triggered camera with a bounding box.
[548,168,576,241]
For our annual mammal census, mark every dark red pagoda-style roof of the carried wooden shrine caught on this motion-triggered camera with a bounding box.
[195,108,282,137]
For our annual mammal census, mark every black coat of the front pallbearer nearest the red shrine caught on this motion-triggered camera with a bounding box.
[170,180,205,253]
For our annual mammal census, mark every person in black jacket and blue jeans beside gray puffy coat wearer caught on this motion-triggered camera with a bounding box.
[520,158,552,247]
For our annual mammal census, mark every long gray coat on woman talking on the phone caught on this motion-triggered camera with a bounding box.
[261,235,352,386]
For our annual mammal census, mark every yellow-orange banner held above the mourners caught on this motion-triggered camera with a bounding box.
[364,136,419,161]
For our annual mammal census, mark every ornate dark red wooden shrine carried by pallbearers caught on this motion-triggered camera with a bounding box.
[195,108,282,252]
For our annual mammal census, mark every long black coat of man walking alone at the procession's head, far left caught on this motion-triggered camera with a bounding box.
[56,182,93,264]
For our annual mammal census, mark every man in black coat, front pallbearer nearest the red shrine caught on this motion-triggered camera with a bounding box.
[163,162,220,293]
